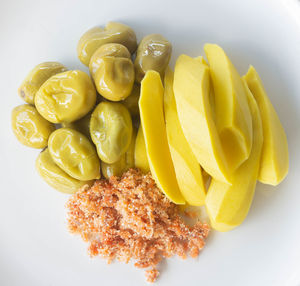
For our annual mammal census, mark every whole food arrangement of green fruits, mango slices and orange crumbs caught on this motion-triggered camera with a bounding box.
[12,22,289,282]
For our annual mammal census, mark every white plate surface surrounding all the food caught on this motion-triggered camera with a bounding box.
[0,0,300,286]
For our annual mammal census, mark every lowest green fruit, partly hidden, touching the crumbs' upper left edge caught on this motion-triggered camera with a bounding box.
[35,148,93,194]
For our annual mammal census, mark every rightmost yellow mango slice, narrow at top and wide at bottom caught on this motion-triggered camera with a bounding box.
[244,66,289,186]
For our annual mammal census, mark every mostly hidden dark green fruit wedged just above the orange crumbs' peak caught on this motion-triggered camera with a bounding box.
[101,128,137,179]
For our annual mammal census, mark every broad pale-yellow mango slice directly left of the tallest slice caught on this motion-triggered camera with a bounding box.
[173,55,230,182]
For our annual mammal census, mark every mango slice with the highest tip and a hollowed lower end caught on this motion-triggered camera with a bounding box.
[204,44,252,171]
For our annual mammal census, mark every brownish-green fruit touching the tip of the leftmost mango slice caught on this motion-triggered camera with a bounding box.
[134,34,172,82]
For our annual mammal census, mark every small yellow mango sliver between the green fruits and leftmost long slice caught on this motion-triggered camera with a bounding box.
[134,125,150,173]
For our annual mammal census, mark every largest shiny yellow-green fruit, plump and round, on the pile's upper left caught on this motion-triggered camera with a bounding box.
[35,70,96,123]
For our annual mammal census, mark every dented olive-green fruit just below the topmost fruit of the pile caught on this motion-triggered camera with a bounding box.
[91,56,134,101]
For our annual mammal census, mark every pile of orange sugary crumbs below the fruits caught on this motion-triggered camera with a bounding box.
[67,169,209,282]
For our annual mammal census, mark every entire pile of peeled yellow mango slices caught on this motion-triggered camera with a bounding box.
[135,44,289,231]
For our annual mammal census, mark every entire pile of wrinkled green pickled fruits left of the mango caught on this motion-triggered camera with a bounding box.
[11,22,172,194]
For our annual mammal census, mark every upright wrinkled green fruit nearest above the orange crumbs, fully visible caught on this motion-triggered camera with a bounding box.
[90,101,132,164]
